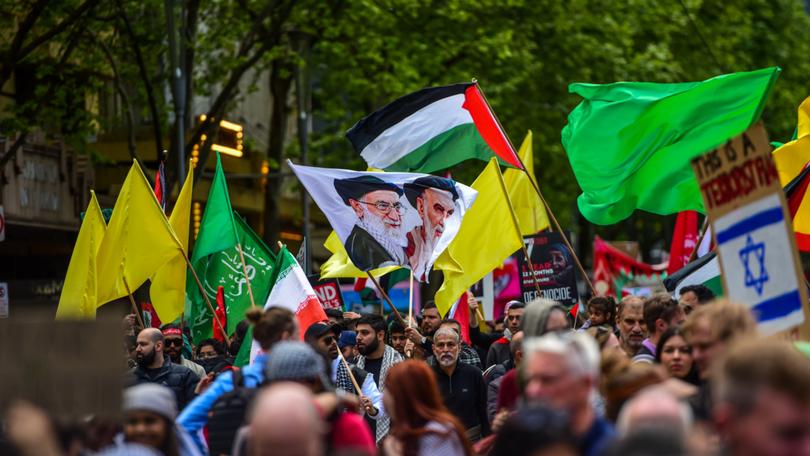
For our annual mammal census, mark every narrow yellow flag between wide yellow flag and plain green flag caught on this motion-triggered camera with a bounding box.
[149,166,194,323]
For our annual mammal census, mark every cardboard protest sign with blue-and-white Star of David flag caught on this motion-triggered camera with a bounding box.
[692,124,807,335]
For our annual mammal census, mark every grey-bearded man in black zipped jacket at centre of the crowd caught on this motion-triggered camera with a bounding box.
[433,326,489,442]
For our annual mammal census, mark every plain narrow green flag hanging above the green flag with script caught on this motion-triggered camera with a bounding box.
[191,153,239,264]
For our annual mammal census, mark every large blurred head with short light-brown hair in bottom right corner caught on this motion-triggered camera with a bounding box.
[712,338,810,456]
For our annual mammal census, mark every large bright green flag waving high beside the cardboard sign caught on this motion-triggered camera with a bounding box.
[562,67,781,225]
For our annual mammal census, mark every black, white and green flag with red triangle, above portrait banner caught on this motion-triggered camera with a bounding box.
[346,83,522,173]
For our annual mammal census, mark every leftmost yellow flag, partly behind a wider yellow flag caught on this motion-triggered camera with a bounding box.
[56,190,107,320]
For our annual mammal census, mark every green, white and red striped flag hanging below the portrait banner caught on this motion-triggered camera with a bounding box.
[243,247,328,363]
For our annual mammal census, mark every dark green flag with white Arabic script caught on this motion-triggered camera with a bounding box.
[186,214,276,344]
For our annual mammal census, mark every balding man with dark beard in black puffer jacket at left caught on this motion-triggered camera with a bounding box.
[125,328,200,409]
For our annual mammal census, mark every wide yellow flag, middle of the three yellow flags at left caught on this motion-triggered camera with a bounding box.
[96,160,183,306]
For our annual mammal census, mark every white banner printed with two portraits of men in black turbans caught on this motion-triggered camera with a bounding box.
[289,162,478,282]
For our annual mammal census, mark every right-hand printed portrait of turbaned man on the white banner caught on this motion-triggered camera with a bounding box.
[403,176,458,282]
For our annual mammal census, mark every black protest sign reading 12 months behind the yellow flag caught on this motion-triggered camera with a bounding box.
[517,232,579,307]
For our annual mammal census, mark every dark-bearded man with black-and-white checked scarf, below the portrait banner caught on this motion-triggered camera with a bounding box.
[356,315,402,443]
